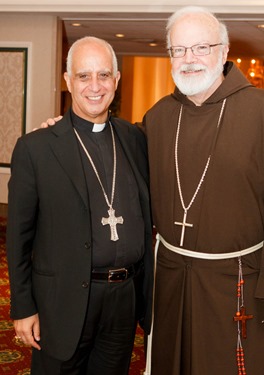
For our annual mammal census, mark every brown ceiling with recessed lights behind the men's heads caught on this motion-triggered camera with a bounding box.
[60,12,264,59]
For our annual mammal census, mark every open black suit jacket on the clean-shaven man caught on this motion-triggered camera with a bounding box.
[7,112,153,360]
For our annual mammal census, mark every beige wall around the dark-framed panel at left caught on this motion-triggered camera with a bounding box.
[0,13,62,203]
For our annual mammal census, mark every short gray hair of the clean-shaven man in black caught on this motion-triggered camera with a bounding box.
[66,36,118,77]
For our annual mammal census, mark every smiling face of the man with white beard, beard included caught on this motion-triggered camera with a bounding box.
[170,13,228,101]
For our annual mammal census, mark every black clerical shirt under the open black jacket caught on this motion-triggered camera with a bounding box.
[71,111,144,268]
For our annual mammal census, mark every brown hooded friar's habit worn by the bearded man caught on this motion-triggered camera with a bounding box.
[143,62,264,375]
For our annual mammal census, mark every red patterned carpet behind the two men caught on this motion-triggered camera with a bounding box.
[0,217,145,375]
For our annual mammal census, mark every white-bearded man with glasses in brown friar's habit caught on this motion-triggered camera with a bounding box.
[144,7,264,375]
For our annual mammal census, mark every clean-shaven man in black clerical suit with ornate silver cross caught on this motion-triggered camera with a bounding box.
[7,37,153,375]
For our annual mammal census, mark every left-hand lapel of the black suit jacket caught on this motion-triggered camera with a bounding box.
[47,113,88,207]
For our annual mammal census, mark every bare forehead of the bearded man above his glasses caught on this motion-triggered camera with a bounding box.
[170,14,220,46]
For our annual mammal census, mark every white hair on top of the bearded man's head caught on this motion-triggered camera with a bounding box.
[166,6,229,48]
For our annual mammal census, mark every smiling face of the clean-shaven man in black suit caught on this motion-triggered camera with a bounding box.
[64,39,120,123]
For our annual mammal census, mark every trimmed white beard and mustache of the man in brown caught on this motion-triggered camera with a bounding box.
[172,56,223,96]
